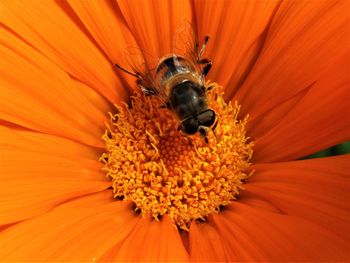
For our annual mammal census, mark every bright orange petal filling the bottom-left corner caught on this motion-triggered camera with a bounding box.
[0,190,139,262]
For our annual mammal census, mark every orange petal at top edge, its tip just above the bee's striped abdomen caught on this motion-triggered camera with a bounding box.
[118,0,192,58]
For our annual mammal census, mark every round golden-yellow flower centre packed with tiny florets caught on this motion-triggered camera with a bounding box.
[101,84,253,230]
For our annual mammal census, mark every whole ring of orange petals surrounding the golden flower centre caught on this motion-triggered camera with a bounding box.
[0,0,350,261]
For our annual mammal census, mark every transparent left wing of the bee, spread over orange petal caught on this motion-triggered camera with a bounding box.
[125,47,168,105]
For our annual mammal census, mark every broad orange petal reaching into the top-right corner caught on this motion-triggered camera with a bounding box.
[234,1,350,118]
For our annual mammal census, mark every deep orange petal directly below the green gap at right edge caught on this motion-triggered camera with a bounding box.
[242,155,350,242]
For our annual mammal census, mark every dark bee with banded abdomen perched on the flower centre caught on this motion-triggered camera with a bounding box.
[115,30,217,143]
